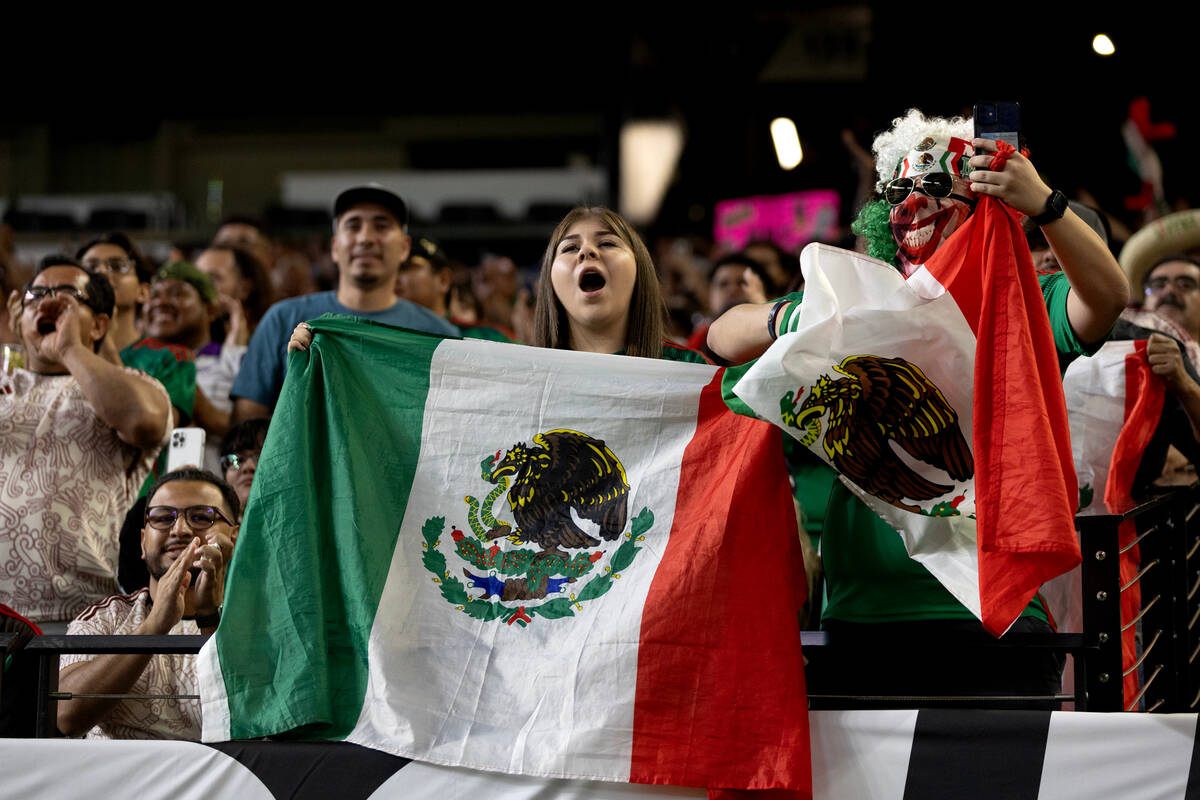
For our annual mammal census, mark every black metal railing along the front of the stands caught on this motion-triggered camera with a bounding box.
[7,485,1200,736]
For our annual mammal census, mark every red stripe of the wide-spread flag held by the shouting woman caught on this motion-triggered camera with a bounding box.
[630,371,812,798]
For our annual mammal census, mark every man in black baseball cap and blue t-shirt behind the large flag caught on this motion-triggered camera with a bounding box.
[229,184,458,421]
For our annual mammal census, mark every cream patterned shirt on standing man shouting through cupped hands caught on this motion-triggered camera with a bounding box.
[0,368,170,622]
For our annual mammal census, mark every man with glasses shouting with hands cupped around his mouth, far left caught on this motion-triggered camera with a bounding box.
[0,255,170,632]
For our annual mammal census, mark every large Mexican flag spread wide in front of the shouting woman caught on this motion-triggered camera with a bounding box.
[199,317,810,793]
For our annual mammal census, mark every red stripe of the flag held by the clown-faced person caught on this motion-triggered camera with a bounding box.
[925,197,1080,636]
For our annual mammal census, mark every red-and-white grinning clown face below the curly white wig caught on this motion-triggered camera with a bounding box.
[889,137,976,276]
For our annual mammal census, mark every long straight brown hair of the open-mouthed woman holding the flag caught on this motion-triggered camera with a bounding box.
[533,206,667,359]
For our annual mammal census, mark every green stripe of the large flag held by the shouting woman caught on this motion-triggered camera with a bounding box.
[216,314,443,739]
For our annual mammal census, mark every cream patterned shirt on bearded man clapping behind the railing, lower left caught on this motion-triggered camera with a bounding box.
[59,589,200,741]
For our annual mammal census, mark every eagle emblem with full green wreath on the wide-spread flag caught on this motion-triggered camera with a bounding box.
[422,428,654,627]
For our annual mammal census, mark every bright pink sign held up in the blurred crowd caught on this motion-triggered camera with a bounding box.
[713,190,840,253]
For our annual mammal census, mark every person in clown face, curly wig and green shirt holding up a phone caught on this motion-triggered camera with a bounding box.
[708,109,1129,696]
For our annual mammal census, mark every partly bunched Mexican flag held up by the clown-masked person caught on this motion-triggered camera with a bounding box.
[736,197,1080,636]
